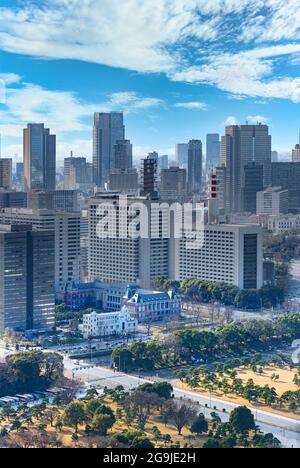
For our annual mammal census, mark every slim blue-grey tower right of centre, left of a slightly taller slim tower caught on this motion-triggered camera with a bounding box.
[188,140,202,193]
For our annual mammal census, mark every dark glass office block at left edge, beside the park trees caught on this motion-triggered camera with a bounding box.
[0,224,55,332]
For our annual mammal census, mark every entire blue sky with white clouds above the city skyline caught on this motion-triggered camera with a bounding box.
[0,0,300,164]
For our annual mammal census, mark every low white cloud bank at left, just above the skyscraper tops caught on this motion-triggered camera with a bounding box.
[0,83,163,137]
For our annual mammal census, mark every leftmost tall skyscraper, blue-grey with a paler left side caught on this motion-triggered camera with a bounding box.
[23,124,56,191]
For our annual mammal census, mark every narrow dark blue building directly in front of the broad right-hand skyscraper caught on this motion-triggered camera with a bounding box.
[243,163,264,213]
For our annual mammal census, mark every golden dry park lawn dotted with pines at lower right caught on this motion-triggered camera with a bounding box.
[175,366,300,419]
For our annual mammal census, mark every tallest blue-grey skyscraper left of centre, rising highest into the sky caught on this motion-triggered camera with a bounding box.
[93,112,125,187]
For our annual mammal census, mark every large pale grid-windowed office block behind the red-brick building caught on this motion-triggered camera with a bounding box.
[88,194,169,288]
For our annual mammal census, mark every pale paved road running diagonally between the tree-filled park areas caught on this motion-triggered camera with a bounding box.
[65,359,300,448]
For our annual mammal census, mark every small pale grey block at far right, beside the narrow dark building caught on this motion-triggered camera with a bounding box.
[256,187,289,215]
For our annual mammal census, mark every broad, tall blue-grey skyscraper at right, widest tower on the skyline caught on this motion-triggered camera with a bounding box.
[221,124,271,212]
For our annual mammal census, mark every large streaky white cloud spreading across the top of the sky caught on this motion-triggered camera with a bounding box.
[0,0,300,101]
